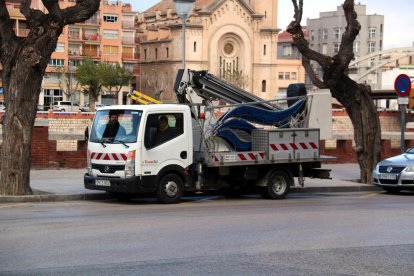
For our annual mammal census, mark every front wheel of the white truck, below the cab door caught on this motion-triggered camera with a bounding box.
[157,173,183,204]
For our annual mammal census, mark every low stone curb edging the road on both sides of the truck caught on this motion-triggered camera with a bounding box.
[0,185,382,203]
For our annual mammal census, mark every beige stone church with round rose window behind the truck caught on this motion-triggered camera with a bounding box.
[137,0,304,102]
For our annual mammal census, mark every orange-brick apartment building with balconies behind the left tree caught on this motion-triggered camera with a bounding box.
[2,0,139,110]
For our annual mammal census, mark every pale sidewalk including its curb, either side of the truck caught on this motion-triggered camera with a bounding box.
[0,164,381,203]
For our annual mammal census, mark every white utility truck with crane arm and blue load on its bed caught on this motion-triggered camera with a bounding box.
[84,70,330,203]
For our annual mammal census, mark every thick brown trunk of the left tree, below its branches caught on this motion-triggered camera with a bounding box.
[0,52,42,195]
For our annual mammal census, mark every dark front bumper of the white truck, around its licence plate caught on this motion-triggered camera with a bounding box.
[83,173,156,194]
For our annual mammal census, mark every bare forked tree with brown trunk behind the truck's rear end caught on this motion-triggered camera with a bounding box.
[287,0,381,183]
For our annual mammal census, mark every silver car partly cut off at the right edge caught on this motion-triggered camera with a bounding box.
[372,148,414,193]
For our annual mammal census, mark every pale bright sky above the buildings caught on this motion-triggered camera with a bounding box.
[129,0,414,49]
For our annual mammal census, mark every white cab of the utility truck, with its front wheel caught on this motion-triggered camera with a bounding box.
[84,104,193,203]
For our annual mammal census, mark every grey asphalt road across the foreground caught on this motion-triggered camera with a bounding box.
[0,192,414,275]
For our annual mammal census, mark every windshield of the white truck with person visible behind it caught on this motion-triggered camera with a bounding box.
[90,109,142,144]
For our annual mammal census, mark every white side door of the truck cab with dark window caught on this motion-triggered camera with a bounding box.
[142,112,192,176]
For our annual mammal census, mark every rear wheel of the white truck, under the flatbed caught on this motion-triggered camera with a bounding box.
[260,170,293,199]
